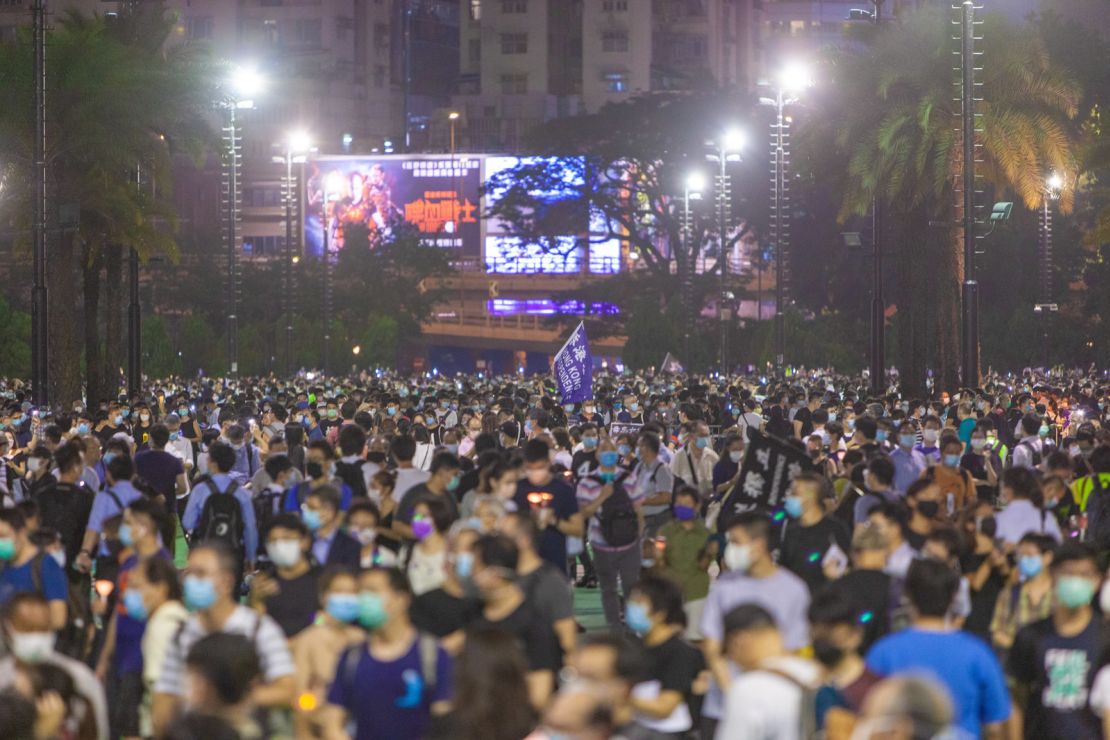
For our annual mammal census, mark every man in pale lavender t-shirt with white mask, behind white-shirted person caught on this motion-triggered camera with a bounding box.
[699,511,809,737]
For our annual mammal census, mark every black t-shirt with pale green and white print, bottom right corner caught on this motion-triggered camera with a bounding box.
[1010,615,1107,740]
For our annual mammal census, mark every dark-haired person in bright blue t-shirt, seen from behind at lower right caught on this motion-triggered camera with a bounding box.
[867,559,1016,738]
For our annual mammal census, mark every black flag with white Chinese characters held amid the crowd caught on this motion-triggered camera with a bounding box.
[720,429,813,521]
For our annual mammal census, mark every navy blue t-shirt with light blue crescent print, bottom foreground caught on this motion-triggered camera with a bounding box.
[327,638,452,740]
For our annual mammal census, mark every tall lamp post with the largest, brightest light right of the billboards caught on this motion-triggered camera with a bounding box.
[759,62,813,373]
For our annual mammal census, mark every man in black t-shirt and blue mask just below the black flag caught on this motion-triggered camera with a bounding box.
[778,473,851,592]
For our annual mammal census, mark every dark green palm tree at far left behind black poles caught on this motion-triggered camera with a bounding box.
[0,3,215,403]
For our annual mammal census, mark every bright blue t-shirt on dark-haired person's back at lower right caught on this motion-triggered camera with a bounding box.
[867,628,1010,737]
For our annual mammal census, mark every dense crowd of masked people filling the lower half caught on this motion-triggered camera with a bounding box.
[0,369,1110,740]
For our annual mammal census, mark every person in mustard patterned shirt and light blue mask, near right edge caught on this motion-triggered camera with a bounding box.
[990,533,1058,651]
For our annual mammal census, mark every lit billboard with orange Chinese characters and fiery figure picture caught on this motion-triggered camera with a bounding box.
[304,155,482,260]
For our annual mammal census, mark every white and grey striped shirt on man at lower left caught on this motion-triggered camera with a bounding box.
[154,606,293,697]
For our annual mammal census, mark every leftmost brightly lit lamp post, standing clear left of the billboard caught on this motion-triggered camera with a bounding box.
[225,67,264,375]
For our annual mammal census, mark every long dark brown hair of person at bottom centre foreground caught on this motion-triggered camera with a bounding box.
[451,627,536,740]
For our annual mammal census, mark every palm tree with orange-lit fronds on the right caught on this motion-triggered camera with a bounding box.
[808,10,1080,389]
